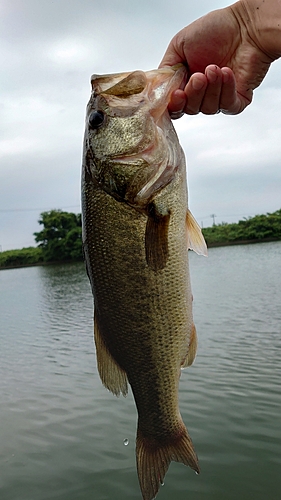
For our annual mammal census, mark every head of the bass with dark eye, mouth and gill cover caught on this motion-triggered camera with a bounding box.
[84,64,186,208]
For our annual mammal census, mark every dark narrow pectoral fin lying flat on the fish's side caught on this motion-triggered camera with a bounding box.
[145,203,170,271]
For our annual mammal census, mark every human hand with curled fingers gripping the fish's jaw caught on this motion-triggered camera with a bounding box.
[160,0,278,116]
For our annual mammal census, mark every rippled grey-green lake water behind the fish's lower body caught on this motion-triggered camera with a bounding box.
[0,242,281,500]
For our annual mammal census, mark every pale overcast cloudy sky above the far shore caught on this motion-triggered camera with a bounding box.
[0,0,281,251]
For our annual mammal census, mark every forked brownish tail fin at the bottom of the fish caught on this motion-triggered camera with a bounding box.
[136,422,197,500]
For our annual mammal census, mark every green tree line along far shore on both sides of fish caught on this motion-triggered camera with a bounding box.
[0,209,281,269]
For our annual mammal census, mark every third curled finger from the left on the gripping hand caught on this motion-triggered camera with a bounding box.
[200,64,222,115]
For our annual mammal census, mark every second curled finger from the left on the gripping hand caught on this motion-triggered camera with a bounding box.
[180,73,208,115]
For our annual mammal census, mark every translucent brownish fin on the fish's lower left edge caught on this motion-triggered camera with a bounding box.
[94,312,128,396]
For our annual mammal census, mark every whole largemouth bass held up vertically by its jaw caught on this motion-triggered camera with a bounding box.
[82,65,207,500]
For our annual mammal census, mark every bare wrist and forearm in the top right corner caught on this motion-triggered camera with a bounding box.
[231,0,281,61]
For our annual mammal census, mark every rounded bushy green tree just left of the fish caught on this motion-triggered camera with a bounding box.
[34,210,82,262]
